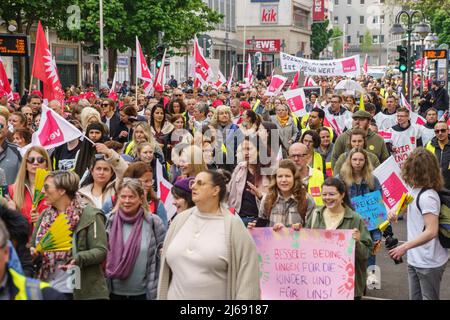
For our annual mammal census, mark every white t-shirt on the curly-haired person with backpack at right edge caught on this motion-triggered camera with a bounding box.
[407,188,448,268]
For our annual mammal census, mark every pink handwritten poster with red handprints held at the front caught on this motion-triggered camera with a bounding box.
[251,228,355,300]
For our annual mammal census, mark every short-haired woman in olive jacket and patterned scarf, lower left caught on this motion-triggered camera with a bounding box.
[30,171,108,300]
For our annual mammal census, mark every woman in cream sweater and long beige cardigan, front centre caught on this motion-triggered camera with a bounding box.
[158,171,260,300]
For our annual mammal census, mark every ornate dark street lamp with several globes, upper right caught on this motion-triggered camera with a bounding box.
[391,10,431,104]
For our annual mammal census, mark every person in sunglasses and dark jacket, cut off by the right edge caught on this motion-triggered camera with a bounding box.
[426,121,450,189]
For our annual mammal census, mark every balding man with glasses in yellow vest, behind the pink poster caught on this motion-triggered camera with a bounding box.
[288,142,324,206]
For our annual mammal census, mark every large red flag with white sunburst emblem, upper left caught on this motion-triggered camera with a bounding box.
[31,21,64,106]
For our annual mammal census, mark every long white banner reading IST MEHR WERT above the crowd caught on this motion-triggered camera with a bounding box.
[280,52,361,77]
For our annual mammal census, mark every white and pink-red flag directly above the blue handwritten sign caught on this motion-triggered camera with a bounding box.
[373,156,409,209]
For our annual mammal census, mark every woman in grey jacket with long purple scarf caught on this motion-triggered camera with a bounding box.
[106,178,166,300]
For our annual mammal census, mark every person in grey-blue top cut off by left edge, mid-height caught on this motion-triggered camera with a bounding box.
[0,114,22,185]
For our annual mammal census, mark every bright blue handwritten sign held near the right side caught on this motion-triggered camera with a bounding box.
[351,191,387,231]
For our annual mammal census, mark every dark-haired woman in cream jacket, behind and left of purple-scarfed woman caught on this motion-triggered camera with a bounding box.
[78,143,128,209]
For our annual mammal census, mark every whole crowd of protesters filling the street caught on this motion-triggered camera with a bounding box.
[0,72,450,300]
